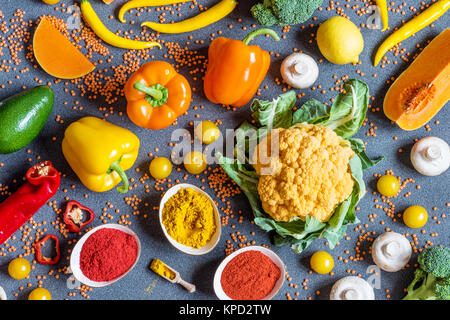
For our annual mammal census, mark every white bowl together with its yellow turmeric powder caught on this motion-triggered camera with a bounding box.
[159,183,222,255]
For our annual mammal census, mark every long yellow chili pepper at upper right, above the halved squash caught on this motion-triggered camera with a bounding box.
[374,0,450,66]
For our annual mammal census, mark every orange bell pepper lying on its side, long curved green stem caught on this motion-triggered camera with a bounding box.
[204,28,280,107]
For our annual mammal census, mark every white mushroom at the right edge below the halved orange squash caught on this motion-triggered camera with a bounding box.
[411,137,450,176]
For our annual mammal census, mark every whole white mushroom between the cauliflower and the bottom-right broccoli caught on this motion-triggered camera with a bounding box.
[372,232,412,272]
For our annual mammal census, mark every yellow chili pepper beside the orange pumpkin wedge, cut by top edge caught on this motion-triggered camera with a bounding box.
[81,0,161,49]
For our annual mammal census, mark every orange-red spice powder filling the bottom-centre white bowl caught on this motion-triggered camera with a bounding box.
[220,250,281,300]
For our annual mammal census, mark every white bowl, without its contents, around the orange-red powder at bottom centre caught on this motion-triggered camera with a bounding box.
[214,246,286,300]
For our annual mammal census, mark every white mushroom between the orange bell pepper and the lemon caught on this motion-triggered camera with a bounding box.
[280,52,319,89]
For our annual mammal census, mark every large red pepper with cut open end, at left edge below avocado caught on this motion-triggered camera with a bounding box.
[0,161,61,245]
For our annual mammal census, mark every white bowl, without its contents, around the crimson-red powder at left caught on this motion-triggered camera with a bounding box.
[70,223,141,288]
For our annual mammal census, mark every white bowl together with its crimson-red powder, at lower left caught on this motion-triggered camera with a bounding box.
[70,223,141,288]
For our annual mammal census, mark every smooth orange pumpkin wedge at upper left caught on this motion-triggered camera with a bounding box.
[33,17,95,79]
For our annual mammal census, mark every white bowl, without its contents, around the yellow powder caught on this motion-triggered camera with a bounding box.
[159,183,222,256]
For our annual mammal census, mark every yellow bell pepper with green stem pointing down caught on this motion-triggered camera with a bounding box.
[62,117,140,193]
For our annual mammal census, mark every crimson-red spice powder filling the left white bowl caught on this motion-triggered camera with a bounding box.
[80,228,138,282]
